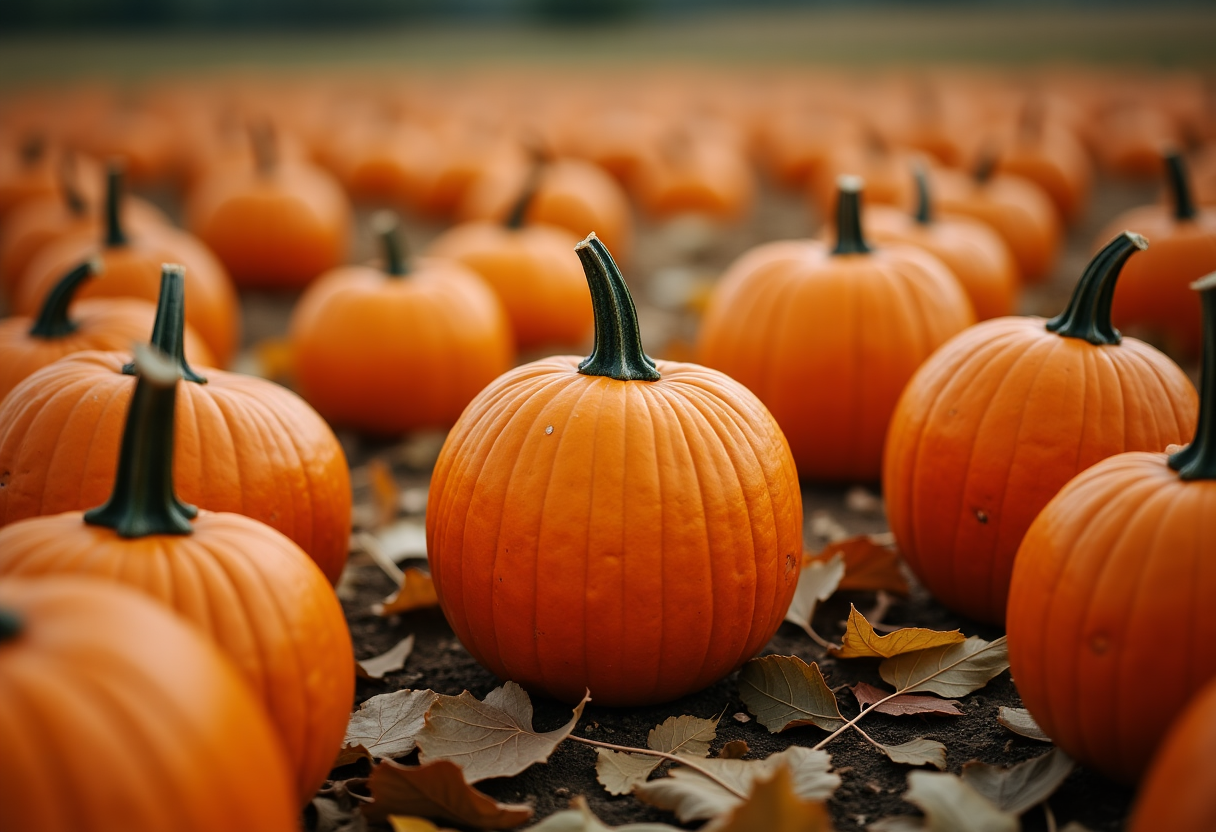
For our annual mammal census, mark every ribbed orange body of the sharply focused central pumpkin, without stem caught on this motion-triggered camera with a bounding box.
[427,355,803,705]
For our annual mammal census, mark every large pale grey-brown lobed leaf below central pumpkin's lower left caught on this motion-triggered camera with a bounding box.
[417,681,591,783]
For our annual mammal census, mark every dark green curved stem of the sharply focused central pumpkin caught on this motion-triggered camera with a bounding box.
[574,231,660,381]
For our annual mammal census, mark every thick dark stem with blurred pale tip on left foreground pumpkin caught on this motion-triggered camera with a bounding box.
[84,344,198,538]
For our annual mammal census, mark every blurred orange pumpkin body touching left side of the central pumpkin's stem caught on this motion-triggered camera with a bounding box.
[428,220,593,349]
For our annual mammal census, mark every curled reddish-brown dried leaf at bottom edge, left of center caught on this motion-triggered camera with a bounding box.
[364,760,533,830]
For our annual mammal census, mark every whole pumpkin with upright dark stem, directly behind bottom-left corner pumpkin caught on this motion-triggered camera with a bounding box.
[0,348,355,804]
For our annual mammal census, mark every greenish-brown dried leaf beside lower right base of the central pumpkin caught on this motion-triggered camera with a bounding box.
[739,656,845,733]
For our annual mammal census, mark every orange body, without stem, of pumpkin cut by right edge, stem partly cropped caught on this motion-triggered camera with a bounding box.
[1007,452,1216,783]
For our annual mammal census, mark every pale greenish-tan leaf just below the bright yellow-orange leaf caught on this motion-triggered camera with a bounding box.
[878,636,1009,697]
